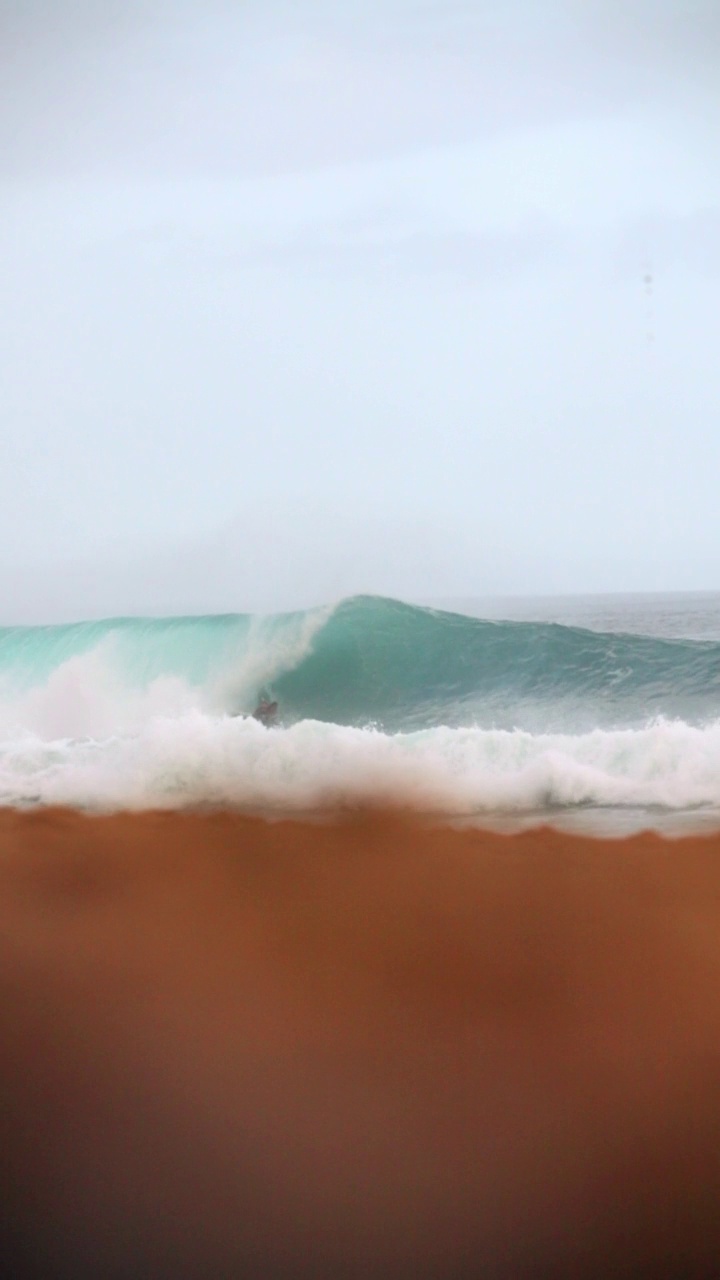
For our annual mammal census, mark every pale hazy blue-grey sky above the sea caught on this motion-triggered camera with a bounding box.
[0,0,720,622]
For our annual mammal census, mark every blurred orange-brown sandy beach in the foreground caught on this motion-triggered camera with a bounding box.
[0,810,720,1280]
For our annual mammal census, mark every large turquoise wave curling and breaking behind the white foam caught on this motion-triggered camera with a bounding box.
[0,596,720,735]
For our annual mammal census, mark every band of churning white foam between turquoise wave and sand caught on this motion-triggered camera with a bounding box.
[0,711,720,815]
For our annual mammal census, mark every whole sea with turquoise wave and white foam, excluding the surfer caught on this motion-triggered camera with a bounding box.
[0,593,720,835]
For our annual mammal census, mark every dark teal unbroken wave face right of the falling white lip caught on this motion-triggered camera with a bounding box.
[274,598,720,731]
